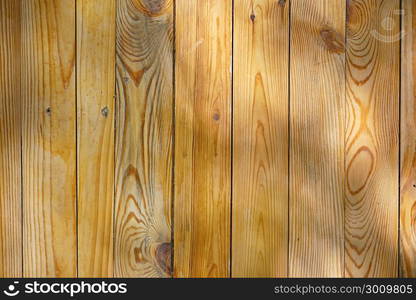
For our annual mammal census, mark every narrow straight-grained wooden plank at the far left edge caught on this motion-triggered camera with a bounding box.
[0,0,22,277]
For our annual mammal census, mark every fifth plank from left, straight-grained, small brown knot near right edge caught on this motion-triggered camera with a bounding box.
[174,0,232,277]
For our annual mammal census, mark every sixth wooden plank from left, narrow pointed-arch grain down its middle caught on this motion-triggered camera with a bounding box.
[232,0,289,277]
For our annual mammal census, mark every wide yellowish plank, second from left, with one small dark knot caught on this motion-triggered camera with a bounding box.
[21,0,77,277]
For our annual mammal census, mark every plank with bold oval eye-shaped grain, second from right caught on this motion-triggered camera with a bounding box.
[345,0,400,277]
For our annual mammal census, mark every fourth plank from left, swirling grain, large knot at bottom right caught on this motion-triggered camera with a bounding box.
[115,0,173,277]
